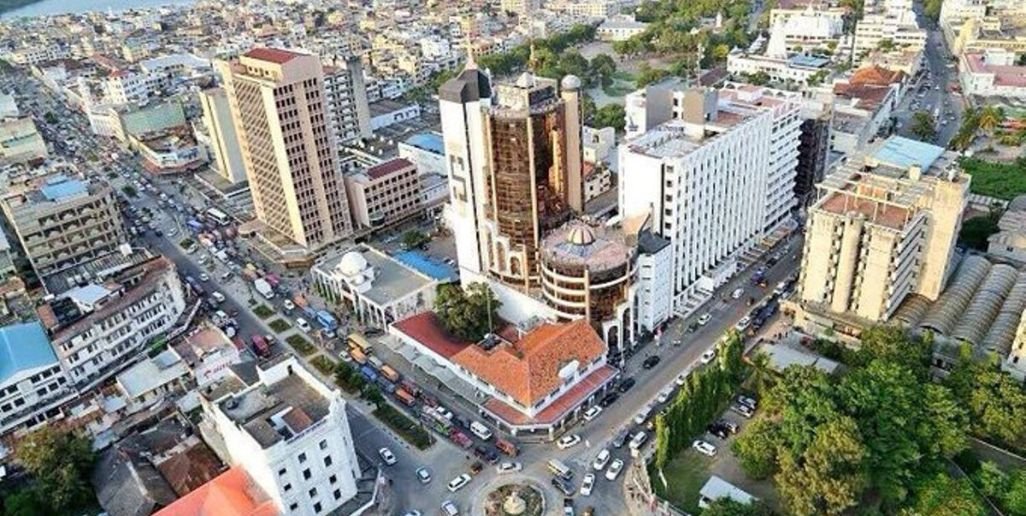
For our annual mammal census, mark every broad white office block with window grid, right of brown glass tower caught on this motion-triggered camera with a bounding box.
[619,83,801,314]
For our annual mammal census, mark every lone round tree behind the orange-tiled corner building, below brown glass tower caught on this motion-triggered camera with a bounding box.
[434,283,502,343]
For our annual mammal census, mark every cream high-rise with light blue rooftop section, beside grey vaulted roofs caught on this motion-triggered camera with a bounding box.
[799,136,970,327]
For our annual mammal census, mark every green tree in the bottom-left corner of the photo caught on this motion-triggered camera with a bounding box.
[15,427,94,514]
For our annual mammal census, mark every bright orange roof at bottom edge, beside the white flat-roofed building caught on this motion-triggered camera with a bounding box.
[154,466,279,516]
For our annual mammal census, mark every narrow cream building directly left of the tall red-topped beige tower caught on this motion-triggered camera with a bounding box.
[199,88,246,184]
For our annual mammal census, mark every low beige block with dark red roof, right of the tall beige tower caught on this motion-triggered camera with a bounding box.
[346,158,424,230]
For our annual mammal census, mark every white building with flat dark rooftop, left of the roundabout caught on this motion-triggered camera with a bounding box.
[202,355,360,516]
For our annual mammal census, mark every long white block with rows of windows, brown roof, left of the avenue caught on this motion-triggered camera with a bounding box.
[37,256,186,391]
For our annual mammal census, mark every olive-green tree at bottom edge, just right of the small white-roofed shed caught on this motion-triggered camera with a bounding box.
[775,416,868,514]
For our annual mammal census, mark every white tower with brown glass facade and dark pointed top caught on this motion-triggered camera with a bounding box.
[439,66,584,289]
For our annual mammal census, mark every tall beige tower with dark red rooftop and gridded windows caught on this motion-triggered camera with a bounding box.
[218,48,352,249]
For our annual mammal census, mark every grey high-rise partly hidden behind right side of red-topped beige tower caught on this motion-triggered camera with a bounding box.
[324,56,371,145]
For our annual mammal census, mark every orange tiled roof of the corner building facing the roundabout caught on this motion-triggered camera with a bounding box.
[450,319,605,406]
